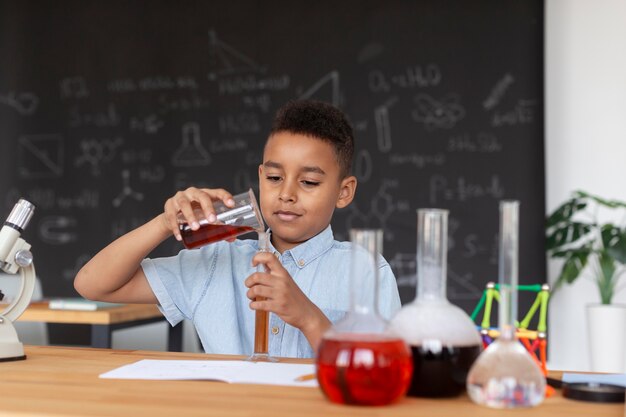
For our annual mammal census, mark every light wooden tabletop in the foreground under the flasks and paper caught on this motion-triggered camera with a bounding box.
[0,346,624,417]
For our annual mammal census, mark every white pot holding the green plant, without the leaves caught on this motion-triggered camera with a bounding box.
[587,304,626,373]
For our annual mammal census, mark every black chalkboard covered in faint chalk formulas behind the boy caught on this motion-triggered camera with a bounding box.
[0,0,545,311]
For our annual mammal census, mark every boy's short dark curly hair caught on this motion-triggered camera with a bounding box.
[270,100,354,178]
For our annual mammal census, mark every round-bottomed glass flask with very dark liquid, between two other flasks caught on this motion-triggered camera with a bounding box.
[389,209,482,397]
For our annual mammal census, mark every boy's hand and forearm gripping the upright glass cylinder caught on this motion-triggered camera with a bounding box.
[245,253,332,350]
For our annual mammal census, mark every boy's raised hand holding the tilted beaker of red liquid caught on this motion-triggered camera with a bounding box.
[163,187,235,241]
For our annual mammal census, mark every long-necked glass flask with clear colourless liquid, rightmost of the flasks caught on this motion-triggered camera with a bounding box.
[467,201,546,408]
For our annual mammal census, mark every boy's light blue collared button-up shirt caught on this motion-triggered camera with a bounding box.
[141,226,400,358]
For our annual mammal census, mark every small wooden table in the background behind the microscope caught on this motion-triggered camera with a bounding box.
[18,303,183,352]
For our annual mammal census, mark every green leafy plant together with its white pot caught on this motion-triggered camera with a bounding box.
[546,191,626,372]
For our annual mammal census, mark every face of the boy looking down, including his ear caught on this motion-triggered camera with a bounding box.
[259,132,356,253]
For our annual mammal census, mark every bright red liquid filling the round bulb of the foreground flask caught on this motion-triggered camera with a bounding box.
[316,334,413,405]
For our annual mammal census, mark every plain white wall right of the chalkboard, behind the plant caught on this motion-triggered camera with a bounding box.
[545,0,626,372]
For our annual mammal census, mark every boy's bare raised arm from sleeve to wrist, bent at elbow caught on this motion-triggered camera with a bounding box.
[74,214,172,303]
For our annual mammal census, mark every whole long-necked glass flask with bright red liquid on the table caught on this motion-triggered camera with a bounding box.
[315,230,413,405]
